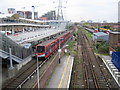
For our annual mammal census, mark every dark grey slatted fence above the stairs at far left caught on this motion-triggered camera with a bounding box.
[0,33,33,59]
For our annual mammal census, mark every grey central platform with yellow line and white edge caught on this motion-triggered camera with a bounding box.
[46,56,74,88]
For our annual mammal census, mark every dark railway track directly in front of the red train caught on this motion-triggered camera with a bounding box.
[2,59,42,90]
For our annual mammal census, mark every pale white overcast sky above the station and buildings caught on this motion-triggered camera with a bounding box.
[0,0,120,22]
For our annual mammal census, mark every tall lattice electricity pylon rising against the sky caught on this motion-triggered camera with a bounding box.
[53,0,67,20]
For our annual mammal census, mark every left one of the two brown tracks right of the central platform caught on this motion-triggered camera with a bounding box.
[81,32,99,88]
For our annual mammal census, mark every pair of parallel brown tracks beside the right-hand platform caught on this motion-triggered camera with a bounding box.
[78,27,117,90]
